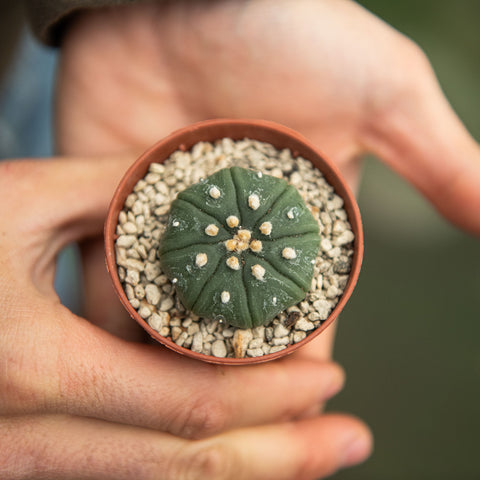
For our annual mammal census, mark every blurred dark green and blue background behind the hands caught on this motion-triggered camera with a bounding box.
[0,0,480,480]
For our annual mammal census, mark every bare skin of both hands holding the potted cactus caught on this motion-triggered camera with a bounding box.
[0,0,480,480]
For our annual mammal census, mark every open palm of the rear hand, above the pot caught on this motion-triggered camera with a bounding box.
[59,0,412,182]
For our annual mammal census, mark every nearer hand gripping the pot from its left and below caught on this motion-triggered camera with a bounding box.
[0,157,370,480]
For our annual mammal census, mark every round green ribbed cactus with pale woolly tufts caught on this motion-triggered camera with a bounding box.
[159,167,320,328]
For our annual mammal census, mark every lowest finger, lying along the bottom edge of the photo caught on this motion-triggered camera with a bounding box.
[0,415,372,480]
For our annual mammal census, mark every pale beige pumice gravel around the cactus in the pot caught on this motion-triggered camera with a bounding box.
[115,138,354,358]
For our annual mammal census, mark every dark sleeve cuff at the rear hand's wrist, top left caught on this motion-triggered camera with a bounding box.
[25,0,136,46]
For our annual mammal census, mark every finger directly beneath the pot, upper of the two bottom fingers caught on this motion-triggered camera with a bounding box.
[0,317,344,438]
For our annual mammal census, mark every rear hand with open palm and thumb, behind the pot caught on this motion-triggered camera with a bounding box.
[58,0,480,357]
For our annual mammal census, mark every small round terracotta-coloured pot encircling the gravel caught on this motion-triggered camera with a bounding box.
[105,119,363,365]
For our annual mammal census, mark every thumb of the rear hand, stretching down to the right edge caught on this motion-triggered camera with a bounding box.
[364,49,480,235]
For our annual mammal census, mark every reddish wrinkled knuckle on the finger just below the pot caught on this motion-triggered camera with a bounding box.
[171,394,230,439]
